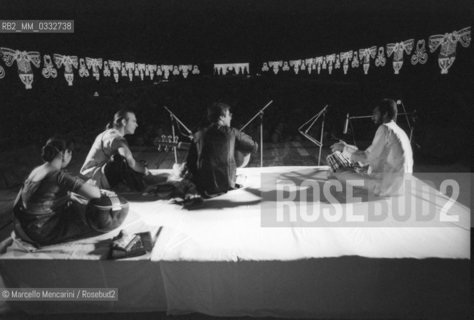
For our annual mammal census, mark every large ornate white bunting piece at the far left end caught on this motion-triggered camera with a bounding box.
[0,48,41,89]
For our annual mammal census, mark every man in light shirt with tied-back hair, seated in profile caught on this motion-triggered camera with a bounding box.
[80,110,150,191]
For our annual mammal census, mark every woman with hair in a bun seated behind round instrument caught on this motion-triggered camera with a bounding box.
[13,138,114,245]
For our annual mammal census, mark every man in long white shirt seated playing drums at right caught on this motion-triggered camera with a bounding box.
[331,99,413,196]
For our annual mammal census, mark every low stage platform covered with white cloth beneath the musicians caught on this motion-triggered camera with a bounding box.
[0,167,470,318]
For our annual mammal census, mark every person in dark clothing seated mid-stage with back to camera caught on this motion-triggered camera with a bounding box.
[186,103,258,198]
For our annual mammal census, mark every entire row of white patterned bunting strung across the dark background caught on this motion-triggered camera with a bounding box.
[0,26,471,89]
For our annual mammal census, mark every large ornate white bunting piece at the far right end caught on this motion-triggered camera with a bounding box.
[429,27,471,74]
